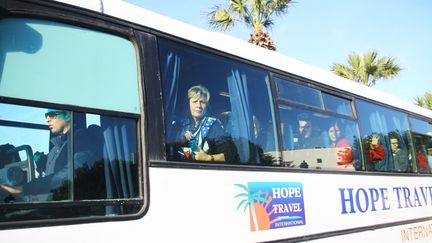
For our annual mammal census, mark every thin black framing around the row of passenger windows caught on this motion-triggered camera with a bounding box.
[149,31,432,176]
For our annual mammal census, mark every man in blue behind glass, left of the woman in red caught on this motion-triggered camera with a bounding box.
[294,114,325,149]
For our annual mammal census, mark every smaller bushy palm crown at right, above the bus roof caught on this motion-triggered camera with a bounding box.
[331,50,402,87]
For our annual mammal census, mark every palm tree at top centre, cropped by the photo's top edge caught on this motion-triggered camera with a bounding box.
[208,0,293,51]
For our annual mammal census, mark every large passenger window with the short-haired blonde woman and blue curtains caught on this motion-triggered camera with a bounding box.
[159,40,277,165]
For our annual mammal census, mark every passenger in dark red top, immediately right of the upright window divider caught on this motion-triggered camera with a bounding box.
[367,133,387,171]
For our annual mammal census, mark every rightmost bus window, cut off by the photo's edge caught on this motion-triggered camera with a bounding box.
[409,117,432,173]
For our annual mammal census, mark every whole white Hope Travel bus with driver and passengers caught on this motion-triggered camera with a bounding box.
[0,0,432,243]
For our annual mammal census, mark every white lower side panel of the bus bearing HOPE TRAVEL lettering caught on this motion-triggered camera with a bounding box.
[0,167,432,242]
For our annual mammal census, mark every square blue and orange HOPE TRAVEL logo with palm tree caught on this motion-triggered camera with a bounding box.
[235,182,306,231]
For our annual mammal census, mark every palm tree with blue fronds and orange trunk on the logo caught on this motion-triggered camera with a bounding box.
[234,184,269,230]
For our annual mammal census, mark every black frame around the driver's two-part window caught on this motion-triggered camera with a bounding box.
[0,1,147,229]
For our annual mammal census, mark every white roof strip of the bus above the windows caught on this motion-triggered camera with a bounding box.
[57,0,432,118]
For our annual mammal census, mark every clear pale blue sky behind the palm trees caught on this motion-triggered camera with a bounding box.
[127,0,432,103]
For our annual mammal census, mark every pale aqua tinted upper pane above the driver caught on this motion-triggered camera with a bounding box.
[0,18,140,114]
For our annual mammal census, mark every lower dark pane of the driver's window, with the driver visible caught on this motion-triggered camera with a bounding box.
[0,103,139,221]
